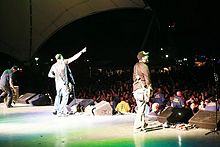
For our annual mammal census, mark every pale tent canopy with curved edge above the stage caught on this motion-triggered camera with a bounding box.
[0,0,145,61]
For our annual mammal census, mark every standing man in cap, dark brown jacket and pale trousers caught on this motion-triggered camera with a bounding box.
[133,51,152,133]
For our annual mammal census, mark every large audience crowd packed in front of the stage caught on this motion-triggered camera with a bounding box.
[69,57,220,127]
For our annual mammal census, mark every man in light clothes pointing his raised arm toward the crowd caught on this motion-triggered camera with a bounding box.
[48,47,86,116]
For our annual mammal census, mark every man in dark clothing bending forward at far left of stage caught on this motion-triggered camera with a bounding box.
[0,66,18,108]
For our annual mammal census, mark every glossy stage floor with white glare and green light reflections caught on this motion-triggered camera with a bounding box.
[0,103,220,147]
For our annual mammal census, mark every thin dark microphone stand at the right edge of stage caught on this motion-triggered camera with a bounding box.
[205,63,219,135]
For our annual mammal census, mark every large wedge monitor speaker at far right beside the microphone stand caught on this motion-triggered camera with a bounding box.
[189,110,220,129]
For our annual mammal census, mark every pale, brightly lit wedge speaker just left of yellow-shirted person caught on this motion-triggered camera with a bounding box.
[93,101,112,115]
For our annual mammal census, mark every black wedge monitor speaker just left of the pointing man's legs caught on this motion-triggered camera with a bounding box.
[28,94,51,106]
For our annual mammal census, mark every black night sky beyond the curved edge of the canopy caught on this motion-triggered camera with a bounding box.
[39,0,220,66]
